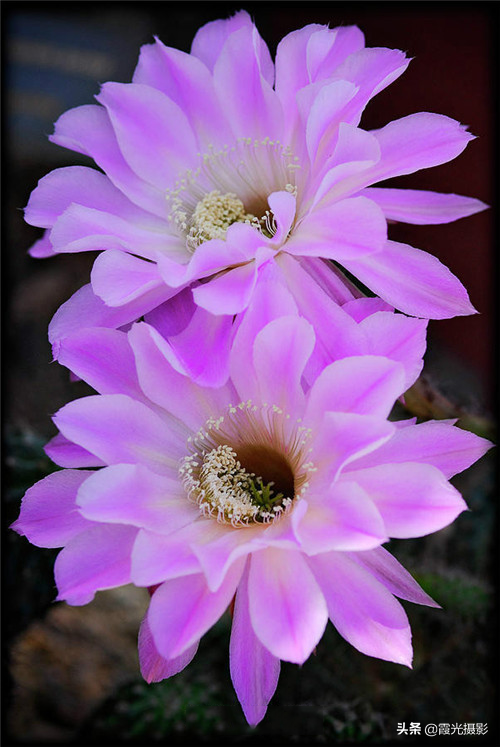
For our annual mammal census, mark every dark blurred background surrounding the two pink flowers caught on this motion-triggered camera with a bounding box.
[2,1,498,744]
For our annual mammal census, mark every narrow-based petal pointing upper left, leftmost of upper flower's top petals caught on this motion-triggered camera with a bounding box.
[49,105,165,218]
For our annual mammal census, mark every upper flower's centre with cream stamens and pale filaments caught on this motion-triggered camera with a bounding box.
[166,138,300,252]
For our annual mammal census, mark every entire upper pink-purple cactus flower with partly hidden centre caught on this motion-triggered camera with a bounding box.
[26,11,485,384]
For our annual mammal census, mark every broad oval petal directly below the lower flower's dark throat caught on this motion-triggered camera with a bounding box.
[248,547,328,664]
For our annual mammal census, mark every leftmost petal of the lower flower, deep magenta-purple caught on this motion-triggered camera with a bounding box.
[11,469,94,547]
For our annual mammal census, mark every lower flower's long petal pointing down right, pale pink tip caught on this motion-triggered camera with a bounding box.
[310,553,412,667]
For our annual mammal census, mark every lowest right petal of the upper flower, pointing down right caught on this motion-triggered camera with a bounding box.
[343,241,475,319]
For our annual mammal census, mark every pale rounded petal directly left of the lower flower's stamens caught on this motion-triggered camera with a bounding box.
[77,464,199,534]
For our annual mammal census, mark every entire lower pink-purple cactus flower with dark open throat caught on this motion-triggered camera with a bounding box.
[14,312,490,724]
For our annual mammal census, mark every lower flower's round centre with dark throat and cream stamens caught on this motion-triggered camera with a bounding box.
[179,401,314,526]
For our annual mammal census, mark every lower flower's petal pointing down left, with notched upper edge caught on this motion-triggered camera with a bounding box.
[148,559,245,659]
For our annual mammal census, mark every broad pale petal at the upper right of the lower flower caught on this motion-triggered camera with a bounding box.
[304,355,404,423]
